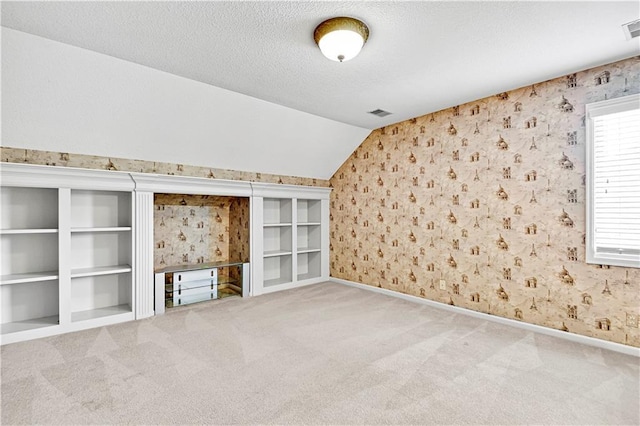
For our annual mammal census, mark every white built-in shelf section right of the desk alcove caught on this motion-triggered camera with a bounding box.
[252,184,330,295]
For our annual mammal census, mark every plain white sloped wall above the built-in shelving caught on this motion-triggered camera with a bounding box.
[1,28,370,179]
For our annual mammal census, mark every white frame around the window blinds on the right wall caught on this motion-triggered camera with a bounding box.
[585,94,640,268]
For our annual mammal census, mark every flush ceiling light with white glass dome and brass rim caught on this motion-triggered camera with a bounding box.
[313,16,369,62]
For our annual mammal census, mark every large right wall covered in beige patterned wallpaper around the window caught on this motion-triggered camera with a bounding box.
[330,58,640,346]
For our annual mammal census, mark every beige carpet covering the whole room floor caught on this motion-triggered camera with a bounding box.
[1,283,640,425]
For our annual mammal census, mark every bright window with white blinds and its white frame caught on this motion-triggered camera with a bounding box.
[586,95,640,268]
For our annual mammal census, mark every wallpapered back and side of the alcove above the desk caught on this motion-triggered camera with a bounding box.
[153,194,249,269]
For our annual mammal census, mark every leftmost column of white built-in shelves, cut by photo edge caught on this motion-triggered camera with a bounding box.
[0,186,59,335]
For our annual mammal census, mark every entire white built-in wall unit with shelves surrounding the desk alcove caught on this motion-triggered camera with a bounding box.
[0,163,330,344]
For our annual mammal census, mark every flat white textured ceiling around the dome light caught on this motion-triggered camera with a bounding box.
[2,1,640,129]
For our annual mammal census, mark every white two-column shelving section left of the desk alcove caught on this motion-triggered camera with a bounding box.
[0,165,134,343]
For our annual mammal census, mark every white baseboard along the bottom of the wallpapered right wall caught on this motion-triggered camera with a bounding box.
[330,277,640,358]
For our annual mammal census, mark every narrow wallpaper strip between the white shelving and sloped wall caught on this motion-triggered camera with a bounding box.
[0,147,329,187]
